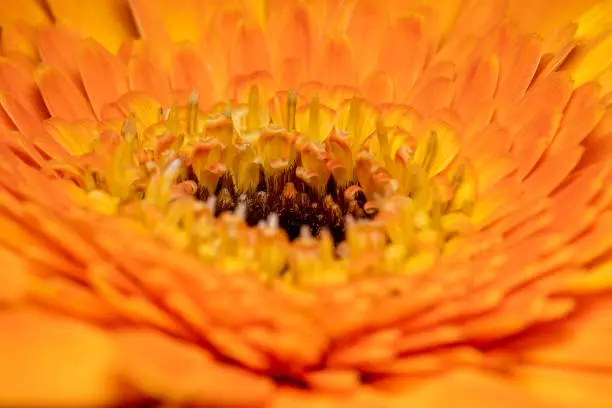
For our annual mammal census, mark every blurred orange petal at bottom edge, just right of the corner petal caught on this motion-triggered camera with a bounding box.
[115,329,272,407]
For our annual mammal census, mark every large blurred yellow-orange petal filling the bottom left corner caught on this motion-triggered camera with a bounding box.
[0,310,130,407]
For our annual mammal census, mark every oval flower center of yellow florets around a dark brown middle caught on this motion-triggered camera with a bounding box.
[64,81,476,282]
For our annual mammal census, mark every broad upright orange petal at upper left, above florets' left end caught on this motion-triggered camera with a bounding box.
[79,40,128,118]
